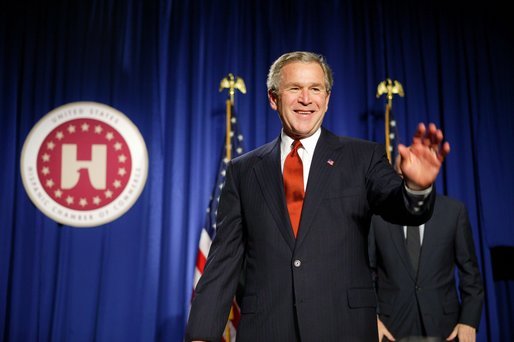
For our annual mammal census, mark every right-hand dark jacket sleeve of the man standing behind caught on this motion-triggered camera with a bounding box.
[455,204,484,328]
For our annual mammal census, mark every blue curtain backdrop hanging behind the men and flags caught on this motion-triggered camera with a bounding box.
[0,0,514,341]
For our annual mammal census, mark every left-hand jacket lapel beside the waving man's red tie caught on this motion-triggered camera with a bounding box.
[254,138,295,251]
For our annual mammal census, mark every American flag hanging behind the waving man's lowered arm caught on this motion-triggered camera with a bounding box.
[193,110,243,342]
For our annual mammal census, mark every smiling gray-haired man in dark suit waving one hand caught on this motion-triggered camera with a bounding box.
[186,52,450,342]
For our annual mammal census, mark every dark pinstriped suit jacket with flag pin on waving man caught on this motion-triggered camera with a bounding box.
[186,129,434,342]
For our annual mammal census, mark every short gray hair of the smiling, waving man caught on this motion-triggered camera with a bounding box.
[266,51,334,93]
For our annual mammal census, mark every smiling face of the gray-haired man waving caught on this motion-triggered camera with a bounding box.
[268,62,330,139]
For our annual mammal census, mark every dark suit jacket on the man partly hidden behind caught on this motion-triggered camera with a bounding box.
[369,196,484,339]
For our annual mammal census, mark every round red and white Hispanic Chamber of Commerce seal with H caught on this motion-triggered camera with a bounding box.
[20,102,148,227]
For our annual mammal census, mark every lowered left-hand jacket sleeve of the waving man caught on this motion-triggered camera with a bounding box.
[185,163,244,341]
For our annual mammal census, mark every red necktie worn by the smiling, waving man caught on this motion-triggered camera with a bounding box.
[284,140,304,237]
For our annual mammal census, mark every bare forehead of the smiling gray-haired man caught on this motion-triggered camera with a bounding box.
[280,62,325,85]
